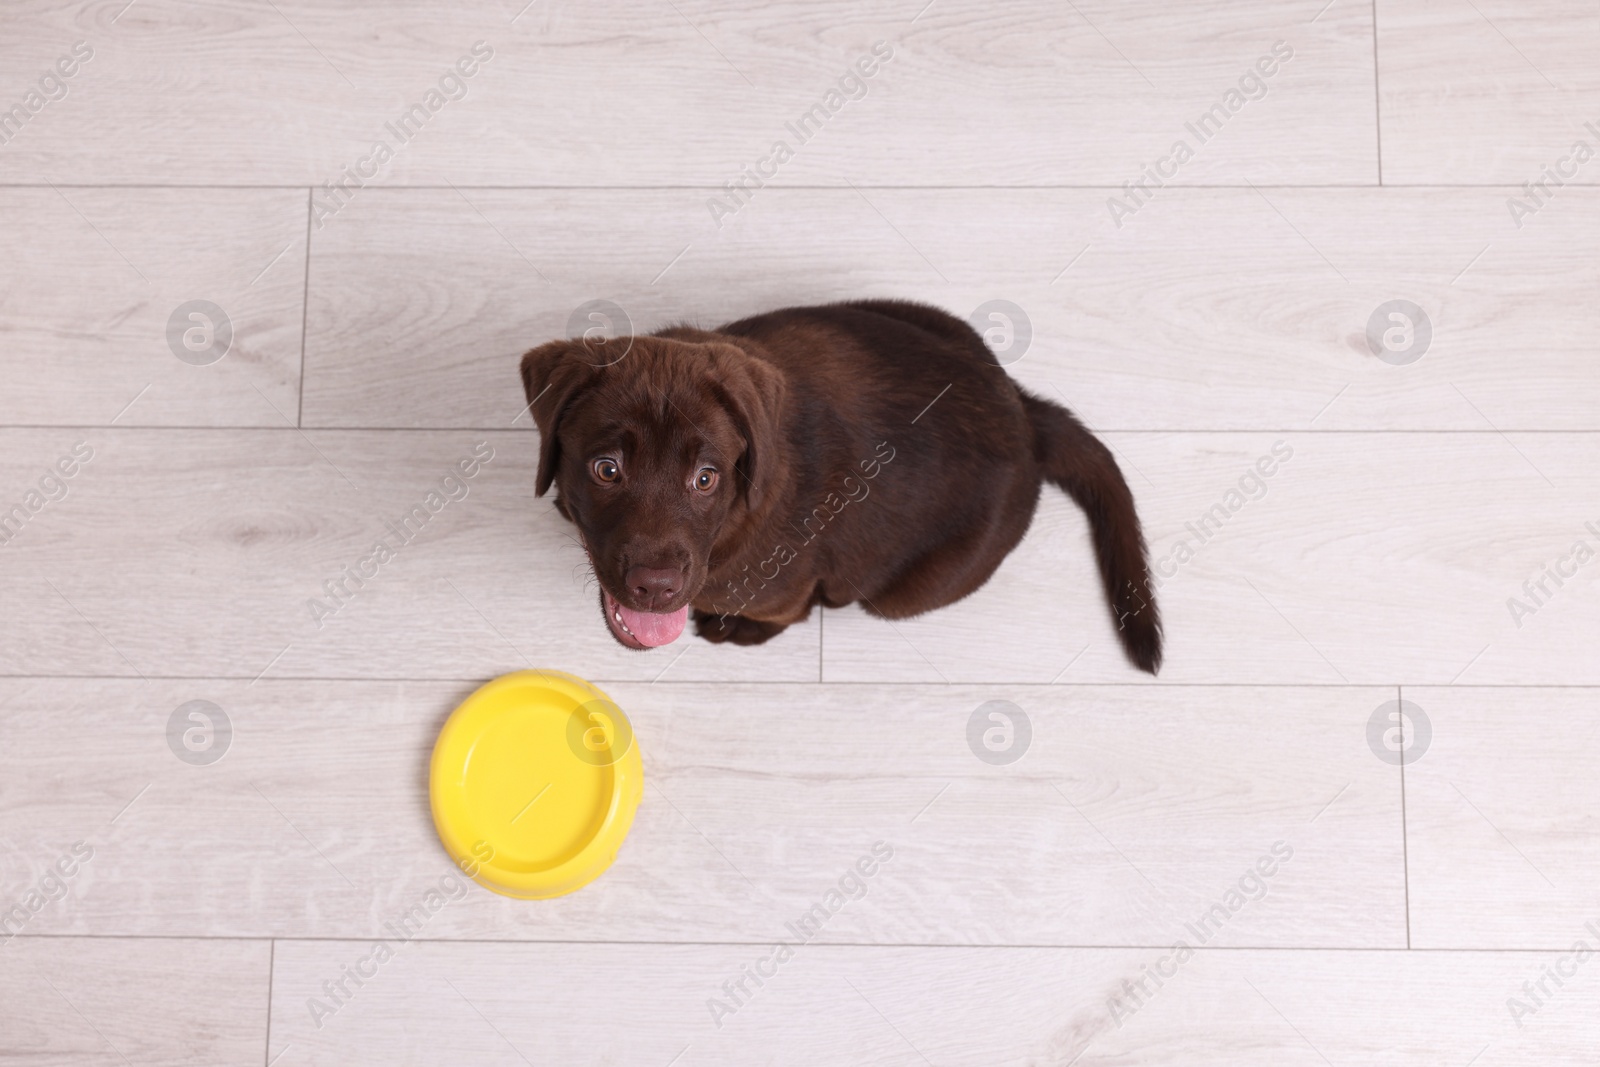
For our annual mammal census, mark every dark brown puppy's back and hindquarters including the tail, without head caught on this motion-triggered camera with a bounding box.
[715,301,1162,673]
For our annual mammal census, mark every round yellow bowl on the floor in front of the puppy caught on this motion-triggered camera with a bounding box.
[427,670,645,899]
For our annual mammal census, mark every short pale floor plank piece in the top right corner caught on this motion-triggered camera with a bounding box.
[1378,0,1600,183]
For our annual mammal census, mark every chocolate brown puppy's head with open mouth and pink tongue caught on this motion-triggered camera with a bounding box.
[522,336,784,649]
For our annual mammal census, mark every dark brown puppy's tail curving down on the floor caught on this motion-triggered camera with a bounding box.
[1018,389,1162,673]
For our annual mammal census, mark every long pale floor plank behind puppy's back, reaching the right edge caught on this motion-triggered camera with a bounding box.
[306,189,1600,432]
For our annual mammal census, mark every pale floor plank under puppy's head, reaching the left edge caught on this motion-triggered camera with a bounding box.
[0,429,819,681]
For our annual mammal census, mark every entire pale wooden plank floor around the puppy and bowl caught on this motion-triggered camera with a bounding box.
[0,0,1600,1067]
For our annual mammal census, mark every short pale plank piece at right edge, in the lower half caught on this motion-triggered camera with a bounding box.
[1405,686,1600,947]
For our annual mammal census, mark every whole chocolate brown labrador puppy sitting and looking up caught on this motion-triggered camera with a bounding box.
[522,301,1162,673]
